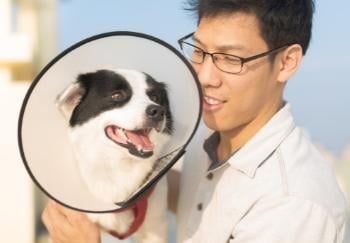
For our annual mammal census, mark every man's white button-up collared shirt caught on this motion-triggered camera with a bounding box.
[177,104,346,243]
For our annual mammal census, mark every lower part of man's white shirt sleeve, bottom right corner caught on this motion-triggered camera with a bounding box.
[228,197,345,243]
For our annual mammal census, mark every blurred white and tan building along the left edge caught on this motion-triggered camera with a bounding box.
[0,0,57,243]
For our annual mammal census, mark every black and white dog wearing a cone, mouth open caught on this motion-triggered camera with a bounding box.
[56,69,173,243]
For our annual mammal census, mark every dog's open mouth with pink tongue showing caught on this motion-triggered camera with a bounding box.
[105,125,154,158]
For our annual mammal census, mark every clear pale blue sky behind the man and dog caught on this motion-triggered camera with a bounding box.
[58,0,350,153]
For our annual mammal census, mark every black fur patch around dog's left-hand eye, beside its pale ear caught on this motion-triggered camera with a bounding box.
[69,70,132,126]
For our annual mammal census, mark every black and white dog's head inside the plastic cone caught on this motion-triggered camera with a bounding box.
[56,69,173,159]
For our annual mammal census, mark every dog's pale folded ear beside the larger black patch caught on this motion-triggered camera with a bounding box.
[56,82,86,121]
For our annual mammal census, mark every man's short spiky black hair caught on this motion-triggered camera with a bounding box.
[185,0,314,55]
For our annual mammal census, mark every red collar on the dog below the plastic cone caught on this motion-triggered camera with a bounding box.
[108,187,154,240]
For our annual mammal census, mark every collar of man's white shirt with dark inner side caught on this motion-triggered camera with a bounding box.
[204,103,295,178]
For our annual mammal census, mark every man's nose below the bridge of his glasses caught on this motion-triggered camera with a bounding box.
[194,55,221,87]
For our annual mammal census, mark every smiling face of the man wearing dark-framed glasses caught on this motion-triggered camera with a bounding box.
[193,13,283,132]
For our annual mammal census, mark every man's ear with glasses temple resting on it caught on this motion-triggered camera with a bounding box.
[277,44,303,83]
